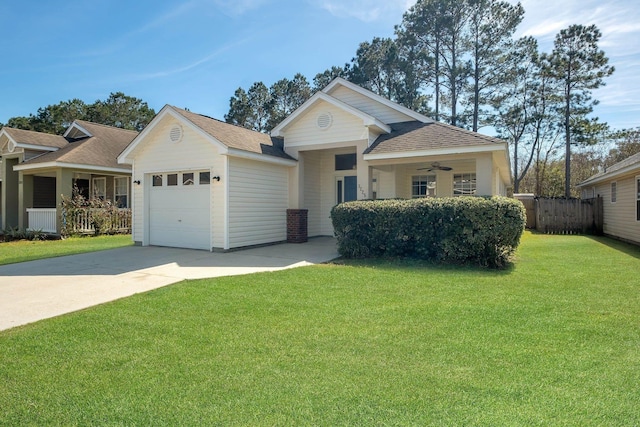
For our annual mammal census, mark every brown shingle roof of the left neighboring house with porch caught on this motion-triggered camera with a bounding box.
[25,120,138,169]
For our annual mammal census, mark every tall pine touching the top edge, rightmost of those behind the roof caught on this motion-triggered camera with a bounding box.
[468,0,524,132]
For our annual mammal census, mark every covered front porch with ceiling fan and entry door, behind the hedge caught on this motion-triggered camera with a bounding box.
[291,144,510,236]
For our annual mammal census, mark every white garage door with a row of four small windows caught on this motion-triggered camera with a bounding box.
[149,171,211,250]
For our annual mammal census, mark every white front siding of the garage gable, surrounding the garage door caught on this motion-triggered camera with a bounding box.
[132,115,226,246]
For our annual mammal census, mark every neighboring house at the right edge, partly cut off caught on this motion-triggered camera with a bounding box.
[578,153,640,244]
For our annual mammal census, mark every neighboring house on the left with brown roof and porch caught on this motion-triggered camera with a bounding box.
[0,120,138,234]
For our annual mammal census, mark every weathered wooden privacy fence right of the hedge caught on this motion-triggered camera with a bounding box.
[516,196,603,234]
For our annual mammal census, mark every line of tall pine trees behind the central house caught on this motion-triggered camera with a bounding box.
[225,0,619,197]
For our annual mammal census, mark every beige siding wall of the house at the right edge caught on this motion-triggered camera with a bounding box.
[596,169,640,243]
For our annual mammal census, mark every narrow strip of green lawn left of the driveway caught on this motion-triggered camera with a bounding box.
[0,234,133,265]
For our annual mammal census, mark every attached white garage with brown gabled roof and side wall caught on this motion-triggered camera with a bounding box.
[118,105,297,251]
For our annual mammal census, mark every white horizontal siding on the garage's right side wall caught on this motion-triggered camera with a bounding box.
[228,157,289,249]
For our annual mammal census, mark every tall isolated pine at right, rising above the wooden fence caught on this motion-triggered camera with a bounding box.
[551,25,614,198]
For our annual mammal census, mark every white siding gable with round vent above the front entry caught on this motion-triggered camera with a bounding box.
[285,101,369,147]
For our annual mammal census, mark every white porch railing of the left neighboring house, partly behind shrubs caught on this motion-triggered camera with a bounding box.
[27,208,131,234]
